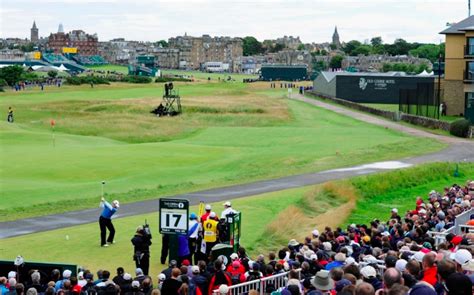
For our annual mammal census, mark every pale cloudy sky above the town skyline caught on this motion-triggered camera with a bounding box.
[0,0,468,43]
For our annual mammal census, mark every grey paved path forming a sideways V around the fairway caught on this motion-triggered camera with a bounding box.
[0,96,474,239]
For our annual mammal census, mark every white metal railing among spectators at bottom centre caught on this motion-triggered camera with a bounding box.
[212,269,301,295]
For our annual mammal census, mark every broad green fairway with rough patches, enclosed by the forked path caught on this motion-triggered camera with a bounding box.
[0,82,444,220]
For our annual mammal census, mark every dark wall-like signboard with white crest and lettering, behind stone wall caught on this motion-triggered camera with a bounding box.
[336,74,434,104]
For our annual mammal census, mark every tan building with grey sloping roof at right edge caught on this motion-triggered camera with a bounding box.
[440,16,474,122]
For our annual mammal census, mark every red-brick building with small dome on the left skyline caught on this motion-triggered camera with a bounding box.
[47,24,98,55]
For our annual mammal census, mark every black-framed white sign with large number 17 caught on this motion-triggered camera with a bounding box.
[160,198,189,234]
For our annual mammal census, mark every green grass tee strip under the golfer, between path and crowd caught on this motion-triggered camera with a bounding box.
[0,187,322,279]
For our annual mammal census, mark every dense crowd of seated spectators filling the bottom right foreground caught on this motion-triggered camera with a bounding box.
[0,181,474,295]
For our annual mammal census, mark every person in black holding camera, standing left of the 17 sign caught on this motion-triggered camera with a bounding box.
[132,225,151,275]
